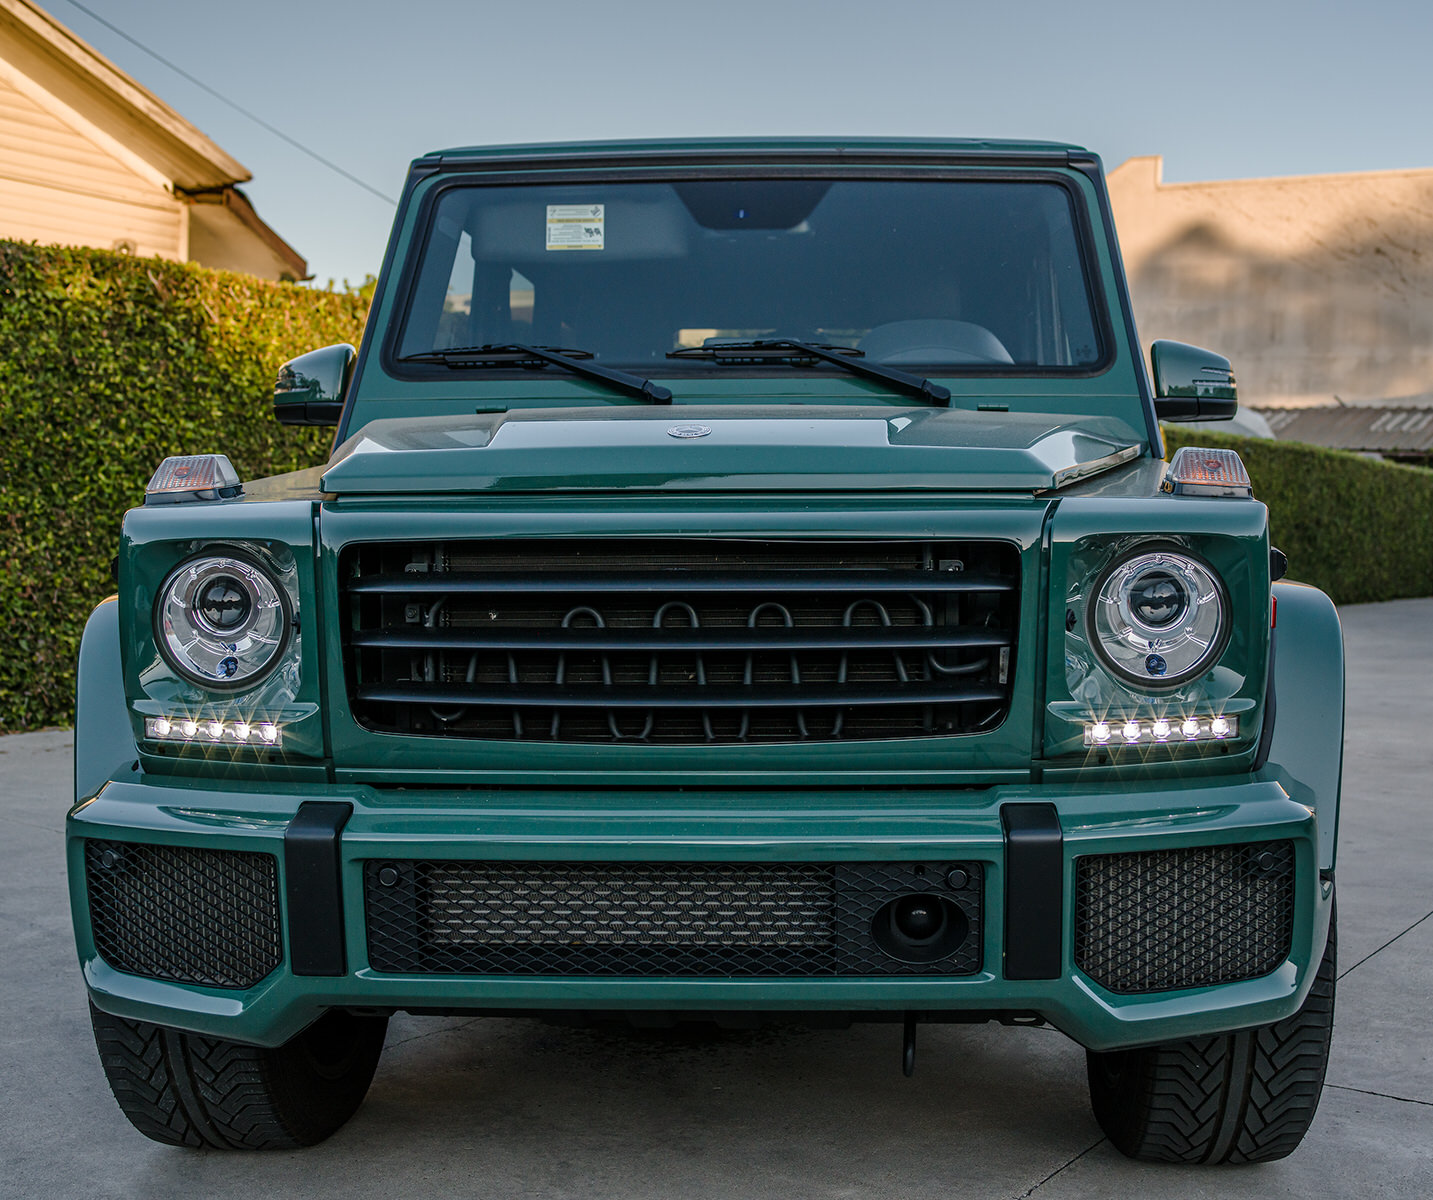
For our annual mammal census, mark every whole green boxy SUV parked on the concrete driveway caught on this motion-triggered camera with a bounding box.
[69,139,1343,1161]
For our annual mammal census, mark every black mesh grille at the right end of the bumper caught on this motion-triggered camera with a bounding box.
[1075,842,1294,994]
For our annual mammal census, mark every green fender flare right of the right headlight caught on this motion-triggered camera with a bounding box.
[1258,582,1344,870]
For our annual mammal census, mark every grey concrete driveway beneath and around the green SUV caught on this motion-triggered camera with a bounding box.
[0,601,1433,1200]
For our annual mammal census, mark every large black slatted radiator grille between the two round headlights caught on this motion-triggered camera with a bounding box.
[341,541,1019,746]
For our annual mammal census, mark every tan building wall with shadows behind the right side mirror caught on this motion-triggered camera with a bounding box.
[1109,158,1433,404]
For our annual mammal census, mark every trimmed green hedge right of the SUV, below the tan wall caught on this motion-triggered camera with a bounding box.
[1165,424,1433,604]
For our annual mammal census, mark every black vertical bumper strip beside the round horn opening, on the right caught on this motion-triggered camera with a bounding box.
[1000,804,1065,979]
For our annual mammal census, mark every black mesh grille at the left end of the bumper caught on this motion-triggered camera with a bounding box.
[85,842,284,988]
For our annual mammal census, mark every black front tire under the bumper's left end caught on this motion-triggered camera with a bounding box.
[90,1005,388,1150]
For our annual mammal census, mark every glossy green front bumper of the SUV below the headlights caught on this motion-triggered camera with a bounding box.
[67,777,1333,1049]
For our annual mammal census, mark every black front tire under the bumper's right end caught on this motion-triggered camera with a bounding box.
[1086,910,1338,1163]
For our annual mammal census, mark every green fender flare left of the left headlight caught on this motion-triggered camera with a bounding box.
[75,596,139,804]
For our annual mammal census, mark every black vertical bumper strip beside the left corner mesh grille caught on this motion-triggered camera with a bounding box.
[284,800,353,975]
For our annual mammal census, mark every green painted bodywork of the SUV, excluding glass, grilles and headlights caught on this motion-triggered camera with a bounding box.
[69,139,1343,1049]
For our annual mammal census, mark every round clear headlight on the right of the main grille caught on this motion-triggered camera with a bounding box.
[1086,551,1230,688]
